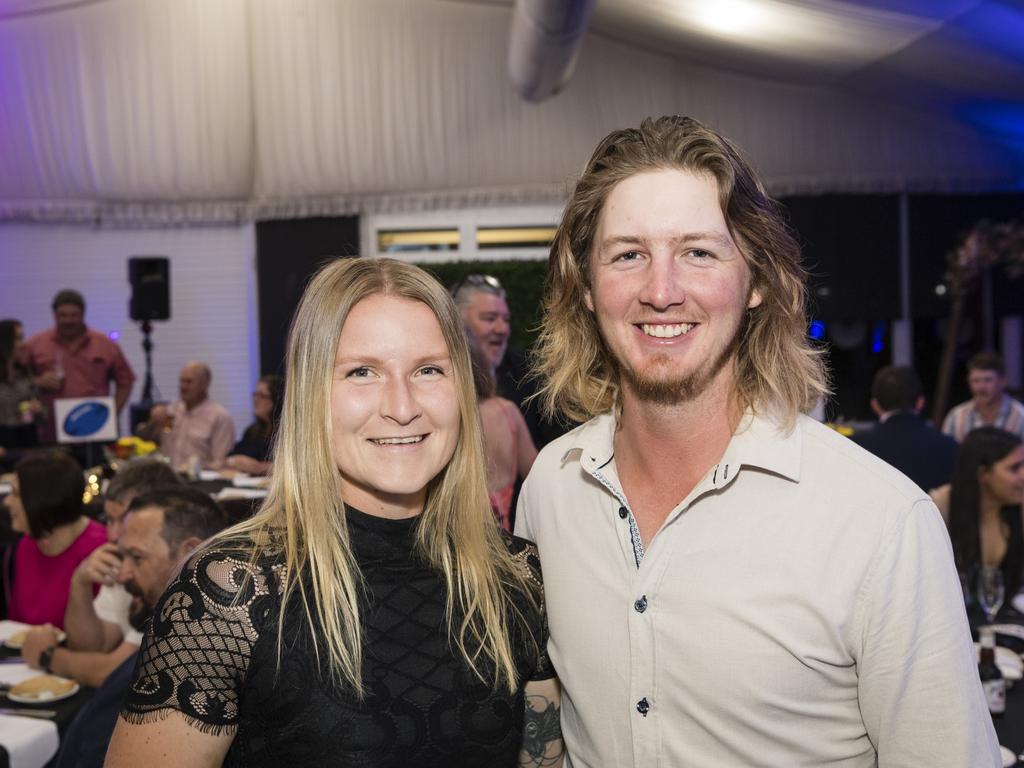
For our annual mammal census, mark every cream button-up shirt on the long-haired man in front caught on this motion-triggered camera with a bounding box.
[516,414,1000,768]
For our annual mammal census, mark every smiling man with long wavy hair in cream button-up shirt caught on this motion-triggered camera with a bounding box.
[517,117,999,768]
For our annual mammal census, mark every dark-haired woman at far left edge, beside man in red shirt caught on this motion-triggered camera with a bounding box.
[0,319,43,456]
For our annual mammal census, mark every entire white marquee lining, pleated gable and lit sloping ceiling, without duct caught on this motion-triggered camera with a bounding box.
[0,0,1024,222]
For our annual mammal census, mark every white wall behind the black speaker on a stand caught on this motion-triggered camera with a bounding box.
[0,222,259,433]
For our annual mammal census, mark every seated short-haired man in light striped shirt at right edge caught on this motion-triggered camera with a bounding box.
[942,352,1024,442]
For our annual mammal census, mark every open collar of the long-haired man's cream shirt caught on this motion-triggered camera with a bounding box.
[561,409,804,486]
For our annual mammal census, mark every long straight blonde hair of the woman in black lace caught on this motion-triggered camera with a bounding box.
[219,258,539,695]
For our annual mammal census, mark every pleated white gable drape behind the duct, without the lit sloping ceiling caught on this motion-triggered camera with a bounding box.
[0,0,1024,225]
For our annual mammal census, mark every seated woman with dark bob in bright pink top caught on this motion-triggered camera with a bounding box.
[3,451,106,628]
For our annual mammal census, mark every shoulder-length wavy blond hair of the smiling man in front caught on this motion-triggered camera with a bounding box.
[536,117,828,423]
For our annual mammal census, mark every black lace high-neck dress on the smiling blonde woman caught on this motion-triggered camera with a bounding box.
[122,510,554,768]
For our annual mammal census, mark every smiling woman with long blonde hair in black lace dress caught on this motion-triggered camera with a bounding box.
[106,259,561,768]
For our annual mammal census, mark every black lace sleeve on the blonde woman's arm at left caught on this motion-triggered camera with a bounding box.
[121,549,283,733]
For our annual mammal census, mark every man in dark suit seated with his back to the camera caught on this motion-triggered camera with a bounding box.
[853,366,957,490]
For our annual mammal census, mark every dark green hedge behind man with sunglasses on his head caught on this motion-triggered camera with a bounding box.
[417,261,548,349]
